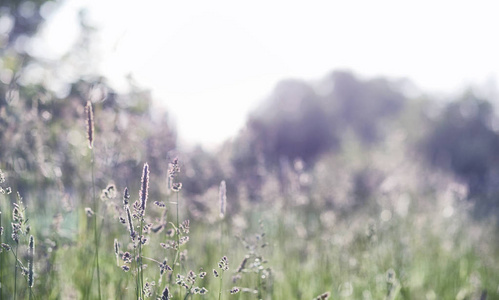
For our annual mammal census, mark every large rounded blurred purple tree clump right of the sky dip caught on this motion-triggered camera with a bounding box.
[232,71,406,198]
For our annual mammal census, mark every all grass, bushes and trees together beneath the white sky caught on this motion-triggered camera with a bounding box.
[0,0,499,300]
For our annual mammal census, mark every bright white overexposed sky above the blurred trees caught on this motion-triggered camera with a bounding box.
[37,0,499,146]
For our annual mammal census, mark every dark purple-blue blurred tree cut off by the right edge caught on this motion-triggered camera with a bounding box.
[422,92,499,213]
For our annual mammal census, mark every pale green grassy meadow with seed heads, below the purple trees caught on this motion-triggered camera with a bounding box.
[0,103,499,299]
